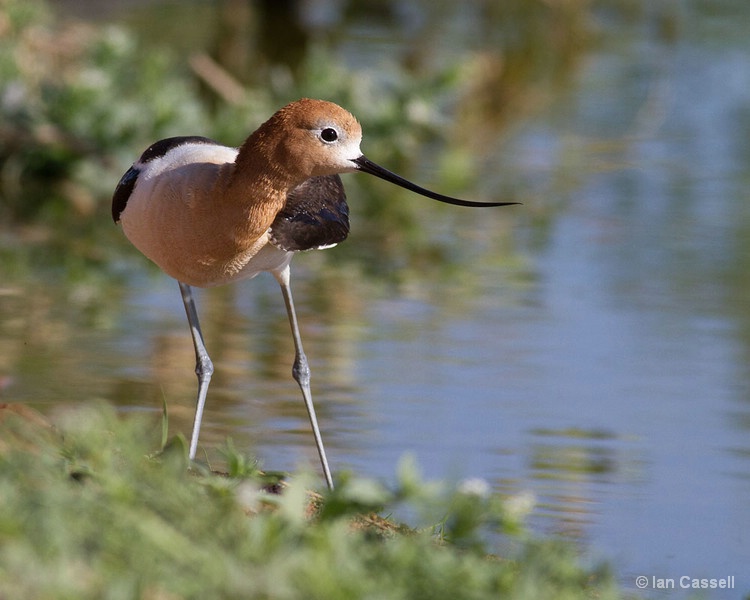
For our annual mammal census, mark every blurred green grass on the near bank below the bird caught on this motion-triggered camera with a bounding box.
[0,405,618,600]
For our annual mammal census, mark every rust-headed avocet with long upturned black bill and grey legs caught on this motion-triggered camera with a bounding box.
[112,98,517,489]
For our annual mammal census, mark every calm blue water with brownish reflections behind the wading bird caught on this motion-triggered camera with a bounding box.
[5,3,750,598]
